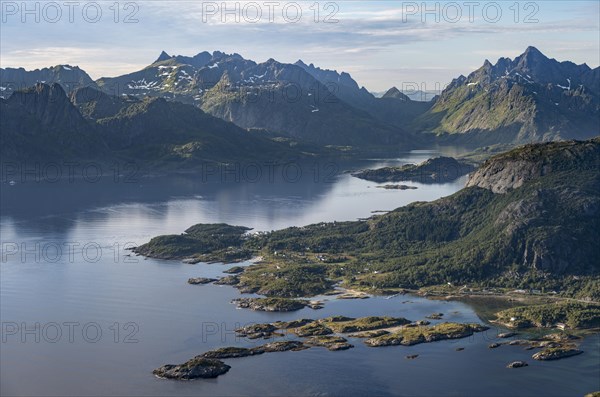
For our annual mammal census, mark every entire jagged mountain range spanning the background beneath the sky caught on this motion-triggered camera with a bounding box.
[0,47,600,158]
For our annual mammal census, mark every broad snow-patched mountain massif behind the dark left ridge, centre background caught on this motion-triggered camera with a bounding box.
[92,51,427,145]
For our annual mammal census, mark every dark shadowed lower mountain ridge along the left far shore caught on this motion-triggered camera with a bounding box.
[0,83,304,168]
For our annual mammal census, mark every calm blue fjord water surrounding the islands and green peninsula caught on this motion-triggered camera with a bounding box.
[0,152,600,396]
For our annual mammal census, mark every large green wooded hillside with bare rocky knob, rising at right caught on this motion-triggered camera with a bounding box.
[136,138,600,299]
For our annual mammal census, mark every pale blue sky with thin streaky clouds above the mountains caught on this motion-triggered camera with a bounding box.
[0,0,600,91]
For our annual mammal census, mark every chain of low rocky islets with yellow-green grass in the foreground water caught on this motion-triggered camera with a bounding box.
[153,310,583,380]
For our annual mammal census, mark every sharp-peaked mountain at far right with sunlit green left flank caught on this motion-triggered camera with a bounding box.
[413,47,600,145]
